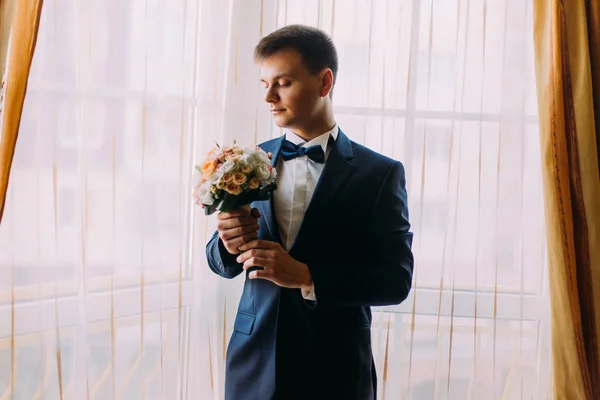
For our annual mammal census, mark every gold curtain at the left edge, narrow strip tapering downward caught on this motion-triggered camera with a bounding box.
[0,0,43,221]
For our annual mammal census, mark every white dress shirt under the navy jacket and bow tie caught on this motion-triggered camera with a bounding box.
[273,125,339,300]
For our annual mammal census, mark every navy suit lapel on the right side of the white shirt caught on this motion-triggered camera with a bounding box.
[288,129,355,252]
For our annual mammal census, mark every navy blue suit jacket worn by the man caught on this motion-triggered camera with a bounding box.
[206,131,413,400]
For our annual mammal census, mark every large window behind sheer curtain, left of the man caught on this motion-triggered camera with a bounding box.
[0,0,198,398]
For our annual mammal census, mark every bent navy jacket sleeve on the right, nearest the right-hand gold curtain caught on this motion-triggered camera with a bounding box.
[309,162,414,308]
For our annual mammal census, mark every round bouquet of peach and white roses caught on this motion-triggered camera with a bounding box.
[194,142,277,215]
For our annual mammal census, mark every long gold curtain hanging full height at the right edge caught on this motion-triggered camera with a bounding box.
[534,0,600,400]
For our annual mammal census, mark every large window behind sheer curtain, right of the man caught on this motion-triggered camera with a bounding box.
[282,0,548,399]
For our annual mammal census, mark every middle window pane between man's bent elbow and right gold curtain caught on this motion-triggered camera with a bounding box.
[409,120,544,292]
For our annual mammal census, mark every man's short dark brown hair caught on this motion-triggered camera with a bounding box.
[254,25,338,93]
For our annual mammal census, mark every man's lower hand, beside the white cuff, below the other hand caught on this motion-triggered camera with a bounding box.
[237,240,313,290]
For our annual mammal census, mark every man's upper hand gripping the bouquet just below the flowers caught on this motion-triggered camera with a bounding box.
[217,207,260,254]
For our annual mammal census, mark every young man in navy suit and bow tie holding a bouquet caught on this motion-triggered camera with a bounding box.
[207,25,413,400]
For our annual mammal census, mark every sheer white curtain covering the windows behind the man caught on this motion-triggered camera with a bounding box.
[0,0,550,400]
